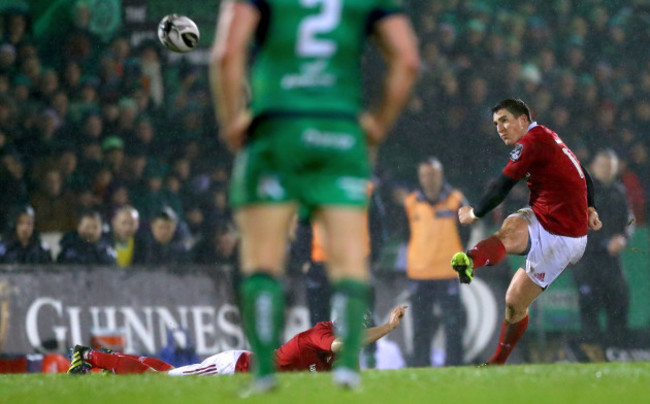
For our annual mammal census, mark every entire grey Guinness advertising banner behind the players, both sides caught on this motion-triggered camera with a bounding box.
[0,266,504,362]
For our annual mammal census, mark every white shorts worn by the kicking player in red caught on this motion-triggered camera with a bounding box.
[512,208,587,289]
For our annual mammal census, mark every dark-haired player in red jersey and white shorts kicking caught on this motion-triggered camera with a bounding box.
[451,99,602,365]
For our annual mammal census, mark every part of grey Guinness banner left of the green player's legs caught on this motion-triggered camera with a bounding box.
[0,267,245,356]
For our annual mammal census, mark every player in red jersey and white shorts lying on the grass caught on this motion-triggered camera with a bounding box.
[68,306,407,376]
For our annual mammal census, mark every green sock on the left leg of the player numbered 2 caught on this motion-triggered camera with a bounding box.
[241,272,284,378]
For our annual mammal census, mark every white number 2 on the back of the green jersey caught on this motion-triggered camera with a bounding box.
[296,0,343,58]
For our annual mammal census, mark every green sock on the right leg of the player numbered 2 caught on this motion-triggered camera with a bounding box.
[332,279,370,371]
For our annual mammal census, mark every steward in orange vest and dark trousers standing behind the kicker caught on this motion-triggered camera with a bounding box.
[404,158,470,366]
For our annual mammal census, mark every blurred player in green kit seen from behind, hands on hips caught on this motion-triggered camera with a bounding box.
[210,0,419,390]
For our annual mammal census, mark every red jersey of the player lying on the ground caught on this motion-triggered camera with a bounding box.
[275,321,335,372]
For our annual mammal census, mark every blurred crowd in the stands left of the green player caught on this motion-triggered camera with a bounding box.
[0,1,236,264]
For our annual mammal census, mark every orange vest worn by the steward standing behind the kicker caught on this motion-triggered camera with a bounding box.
[404,190,464,279]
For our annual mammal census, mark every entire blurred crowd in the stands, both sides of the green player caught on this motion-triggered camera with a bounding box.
[0,0,650,265]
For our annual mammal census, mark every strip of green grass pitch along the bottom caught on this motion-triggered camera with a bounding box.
[0,363,650,404]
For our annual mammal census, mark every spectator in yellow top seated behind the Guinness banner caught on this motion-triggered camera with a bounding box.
[111,206,140,267]
